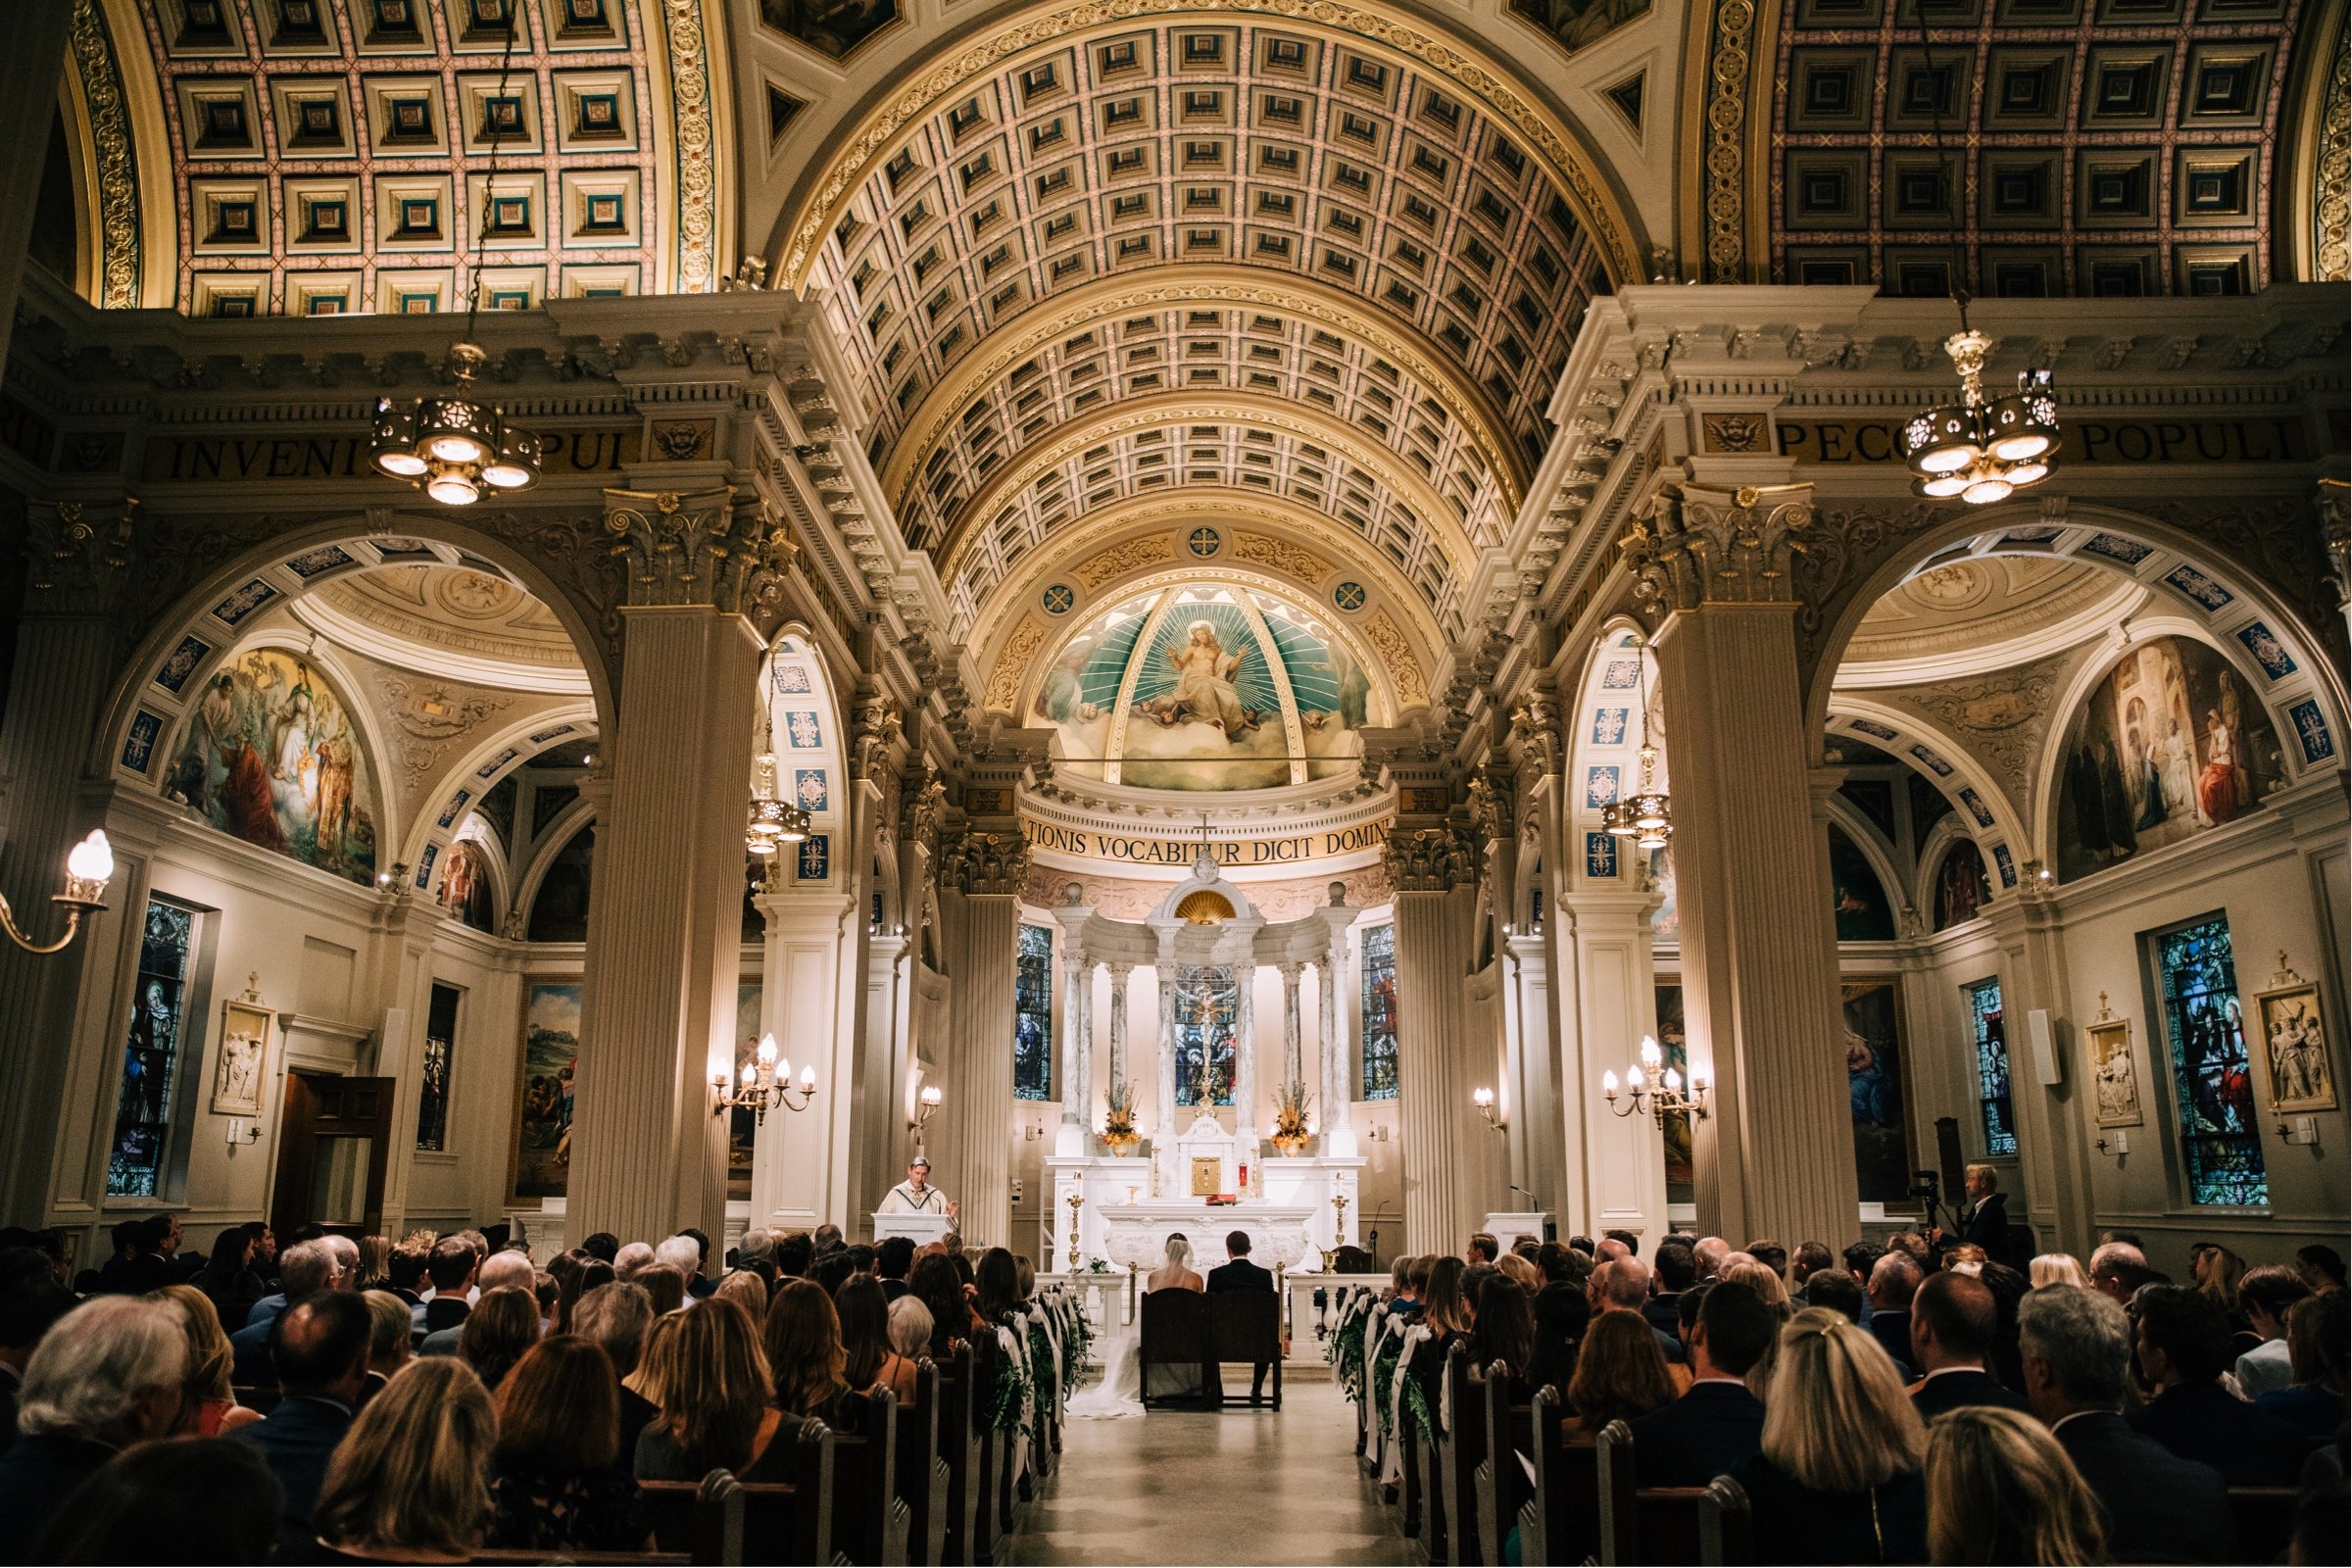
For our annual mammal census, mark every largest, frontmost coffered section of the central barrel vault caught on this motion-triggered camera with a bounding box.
[781,0,1630,496]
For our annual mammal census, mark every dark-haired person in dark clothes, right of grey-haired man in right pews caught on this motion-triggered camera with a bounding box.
[2124,1286,2305,1486]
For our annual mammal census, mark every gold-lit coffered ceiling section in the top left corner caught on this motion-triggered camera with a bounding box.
[75,0,719,315]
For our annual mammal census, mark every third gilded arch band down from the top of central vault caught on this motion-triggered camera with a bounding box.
[939,388,1477,583]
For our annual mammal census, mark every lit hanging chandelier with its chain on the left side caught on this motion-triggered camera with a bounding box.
[369,12,541,506]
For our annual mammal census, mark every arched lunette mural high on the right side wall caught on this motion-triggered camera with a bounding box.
[2058,637,2286,882]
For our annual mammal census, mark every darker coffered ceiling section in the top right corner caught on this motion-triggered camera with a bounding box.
[1769,0,2342,296]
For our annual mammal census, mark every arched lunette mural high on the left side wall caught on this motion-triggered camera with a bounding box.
[165,649,376,884]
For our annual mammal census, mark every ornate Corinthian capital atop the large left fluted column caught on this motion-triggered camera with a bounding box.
[605,484,800,613]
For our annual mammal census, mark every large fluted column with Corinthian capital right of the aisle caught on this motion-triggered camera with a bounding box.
[1625,484,1858,1239]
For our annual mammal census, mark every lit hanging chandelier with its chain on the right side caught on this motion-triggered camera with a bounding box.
[1895,5,2060,506]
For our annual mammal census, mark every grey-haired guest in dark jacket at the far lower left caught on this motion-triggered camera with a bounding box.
[0,1296,188,1563]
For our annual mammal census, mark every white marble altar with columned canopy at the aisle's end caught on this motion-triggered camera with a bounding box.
[1045,851,1364,1269]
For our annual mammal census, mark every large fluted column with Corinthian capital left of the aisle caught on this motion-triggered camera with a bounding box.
[566,487,790,1239]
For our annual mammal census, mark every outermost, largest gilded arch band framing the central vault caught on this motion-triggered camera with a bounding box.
[776,0,1646,289]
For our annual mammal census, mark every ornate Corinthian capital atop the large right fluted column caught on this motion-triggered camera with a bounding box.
[1618,484,1813,613]
